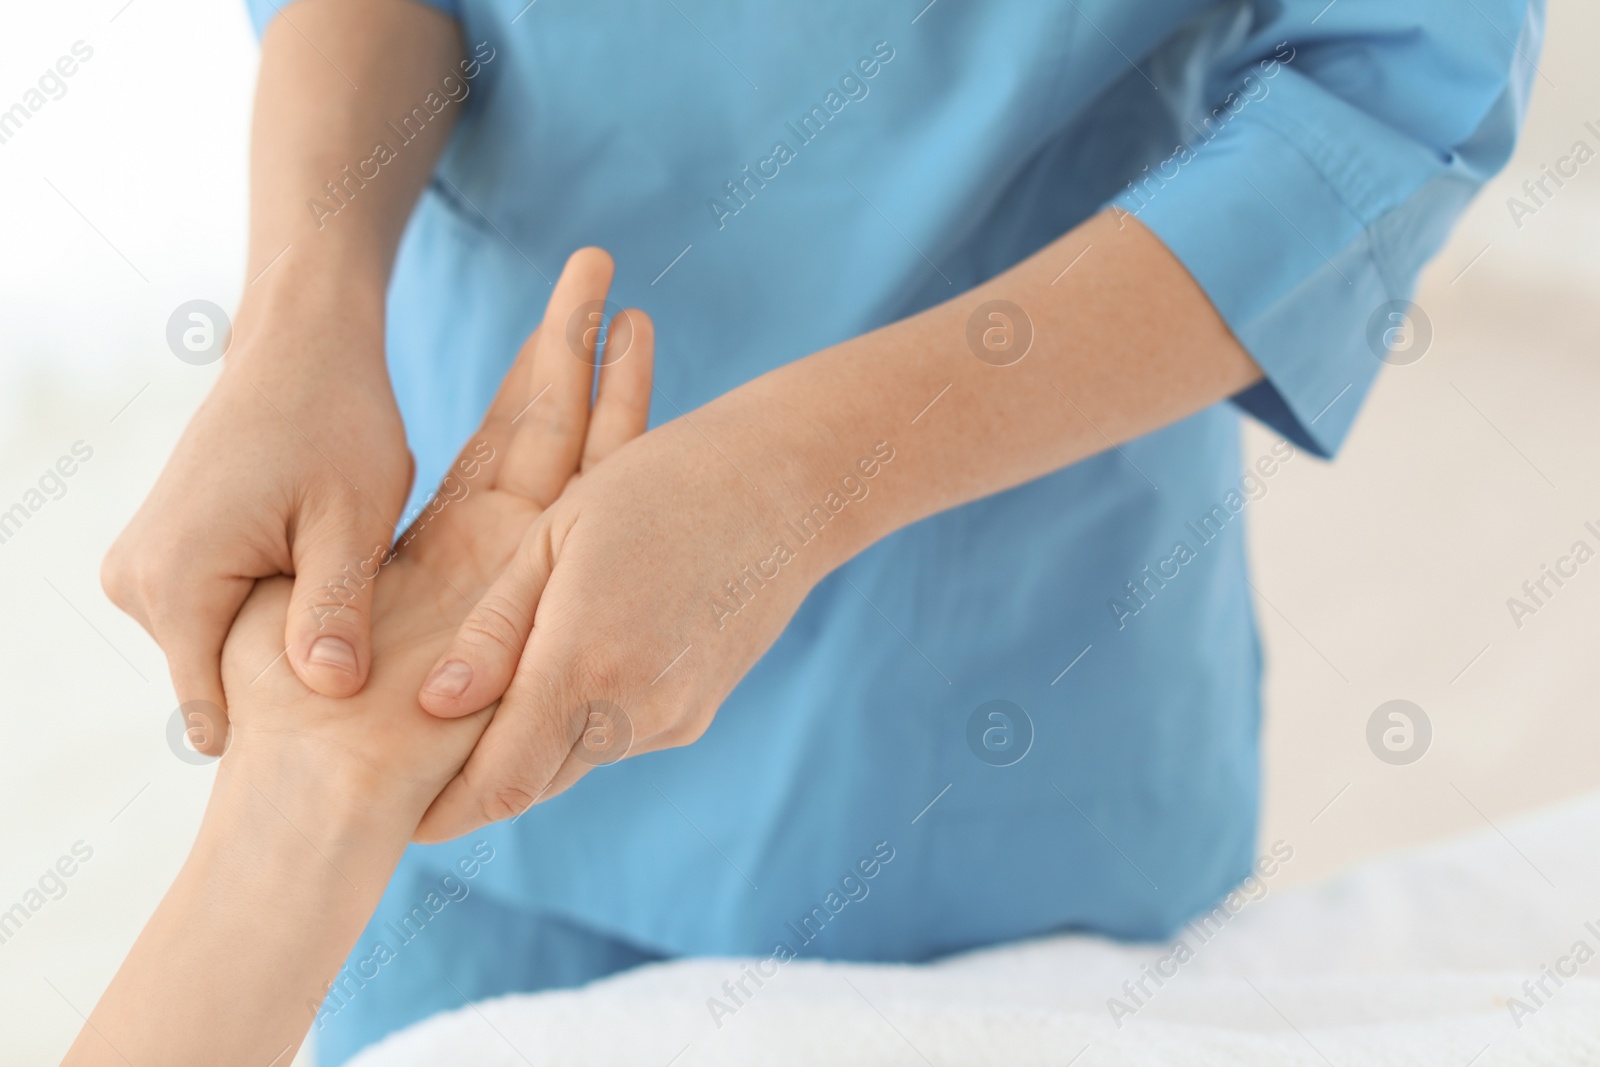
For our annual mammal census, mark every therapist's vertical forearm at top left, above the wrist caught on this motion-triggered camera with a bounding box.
[242,0,475,327]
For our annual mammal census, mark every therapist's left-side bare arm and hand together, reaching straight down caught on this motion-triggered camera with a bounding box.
[101,0,462,742]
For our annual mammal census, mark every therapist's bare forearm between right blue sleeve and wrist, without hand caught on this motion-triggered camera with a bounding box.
[716,214,1261,573]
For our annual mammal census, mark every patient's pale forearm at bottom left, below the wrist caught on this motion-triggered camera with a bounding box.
[64,752,421,1067]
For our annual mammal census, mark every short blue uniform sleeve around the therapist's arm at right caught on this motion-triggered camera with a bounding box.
[1112,0,1544,456]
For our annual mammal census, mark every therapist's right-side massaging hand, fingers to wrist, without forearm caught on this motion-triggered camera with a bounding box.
[418,367,894,841]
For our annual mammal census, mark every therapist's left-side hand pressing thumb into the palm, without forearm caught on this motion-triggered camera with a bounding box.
[101,279,411,739]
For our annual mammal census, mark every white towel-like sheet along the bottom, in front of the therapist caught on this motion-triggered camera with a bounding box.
[352,793,1600,1067]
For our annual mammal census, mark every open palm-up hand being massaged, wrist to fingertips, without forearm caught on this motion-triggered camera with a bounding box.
[222,248,654,832]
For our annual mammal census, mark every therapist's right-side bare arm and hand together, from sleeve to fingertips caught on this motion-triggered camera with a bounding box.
[419,213,1261,841]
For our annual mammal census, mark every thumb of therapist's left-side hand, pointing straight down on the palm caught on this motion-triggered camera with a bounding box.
[283,522,389,697]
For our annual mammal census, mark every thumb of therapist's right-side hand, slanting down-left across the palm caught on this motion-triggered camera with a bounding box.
[418,520,555,718]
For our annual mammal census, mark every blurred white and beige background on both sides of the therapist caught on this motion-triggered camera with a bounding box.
[0,0,1600,1065]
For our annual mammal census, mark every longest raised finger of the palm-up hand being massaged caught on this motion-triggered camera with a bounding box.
[494,248,613,507]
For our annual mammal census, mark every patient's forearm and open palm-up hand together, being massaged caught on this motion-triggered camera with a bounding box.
[64,248,653,1067]
